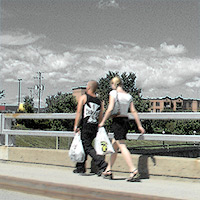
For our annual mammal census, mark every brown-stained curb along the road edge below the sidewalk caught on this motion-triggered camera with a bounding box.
[0,175,179,200]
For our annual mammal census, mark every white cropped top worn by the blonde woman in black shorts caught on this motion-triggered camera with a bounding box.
[109,90,133,116]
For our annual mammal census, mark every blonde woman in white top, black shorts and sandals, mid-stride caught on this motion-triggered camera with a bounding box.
[99,77,145,182]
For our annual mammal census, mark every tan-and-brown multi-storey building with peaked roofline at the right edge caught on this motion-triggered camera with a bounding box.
[146,96,200,112]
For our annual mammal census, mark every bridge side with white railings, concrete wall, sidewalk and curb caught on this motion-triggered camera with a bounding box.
[0,113,200,200]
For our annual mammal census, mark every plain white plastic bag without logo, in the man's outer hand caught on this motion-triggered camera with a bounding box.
[69,133,85,162]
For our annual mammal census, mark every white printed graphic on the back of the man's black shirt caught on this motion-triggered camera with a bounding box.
[84,102,101,124]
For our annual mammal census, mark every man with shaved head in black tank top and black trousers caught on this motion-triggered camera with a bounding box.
[74,81,107,173]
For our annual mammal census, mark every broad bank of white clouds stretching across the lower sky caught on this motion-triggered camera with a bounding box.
[0,31,200,104]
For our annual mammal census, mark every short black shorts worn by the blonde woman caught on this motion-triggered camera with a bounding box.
[112,117,130,140]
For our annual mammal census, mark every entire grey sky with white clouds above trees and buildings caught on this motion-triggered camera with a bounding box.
[0,0,200,107]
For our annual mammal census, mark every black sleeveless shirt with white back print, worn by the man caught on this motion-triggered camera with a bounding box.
[82,93,101,128]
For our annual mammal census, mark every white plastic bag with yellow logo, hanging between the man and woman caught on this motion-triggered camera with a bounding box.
[94,127,115,155]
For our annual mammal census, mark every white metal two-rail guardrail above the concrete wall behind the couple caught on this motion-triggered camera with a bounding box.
[0,112,200,146]
